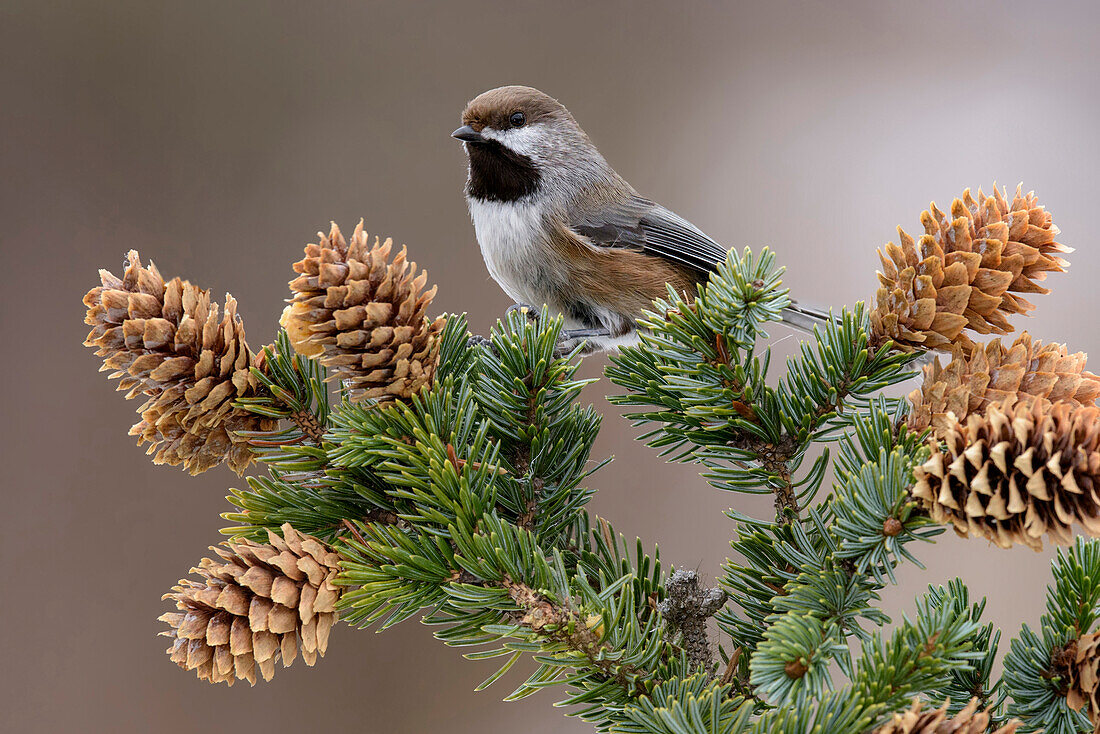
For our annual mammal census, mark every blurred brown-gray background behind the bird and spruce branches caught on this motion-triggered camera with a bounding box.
[0,0,1100,733]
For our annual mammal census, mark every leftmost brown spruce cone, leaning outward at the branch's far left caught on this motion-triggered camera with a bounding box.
[84,250,277,474]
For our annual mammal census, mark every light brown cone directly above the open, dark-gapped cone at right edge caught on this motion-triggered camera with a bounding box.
[909,331,1100,438]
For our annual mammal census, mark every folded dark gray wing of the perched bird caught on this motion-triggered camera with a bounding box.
[571,195,727,274]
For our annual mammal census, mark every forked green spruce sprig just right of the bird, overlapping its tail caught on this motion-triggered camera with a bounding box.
[607,252,912,523]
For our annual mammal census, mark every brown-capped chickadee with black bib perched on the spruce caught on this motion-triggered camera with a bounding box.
[451,86,828,352]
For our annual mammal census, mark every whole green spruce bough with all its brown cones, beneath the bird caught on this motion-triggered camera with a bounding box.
[85,193,1100,734]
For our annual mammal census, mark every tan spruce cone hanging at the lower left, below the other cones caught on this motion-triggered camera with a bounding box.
[160,523,341,686]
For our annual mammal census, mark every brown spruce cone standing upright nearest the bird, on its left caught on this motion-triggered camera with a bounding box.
[283,220,443,399]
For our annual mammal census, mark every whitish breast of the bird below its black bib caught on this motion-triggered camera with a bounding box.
[468,199,559,309]
